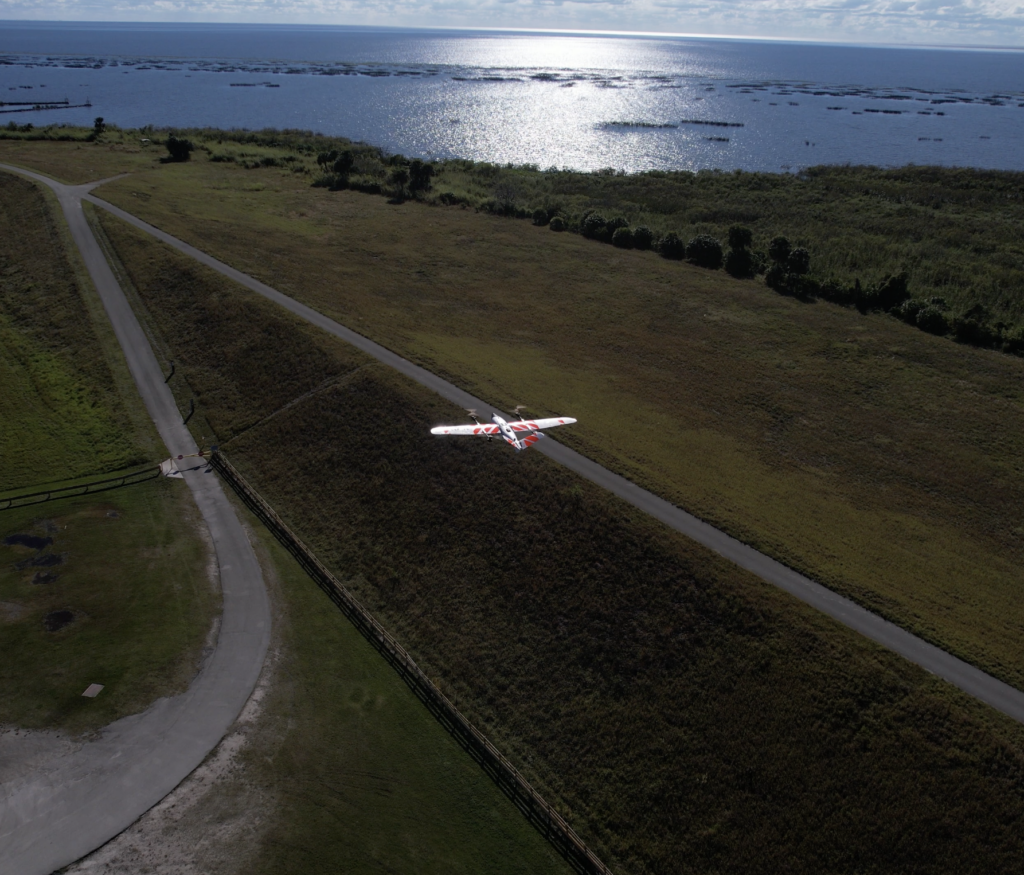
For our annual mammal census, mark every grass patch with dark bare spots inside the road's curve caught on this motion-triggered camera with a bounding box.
[0,480,220,733]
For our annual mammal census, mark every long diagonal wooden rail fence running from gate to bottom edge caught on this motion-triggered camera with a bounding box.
[210,453,611,875]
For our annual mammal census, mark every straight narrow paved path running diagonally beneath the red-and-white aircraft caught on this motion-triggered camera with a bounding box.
[86,185,1024,722]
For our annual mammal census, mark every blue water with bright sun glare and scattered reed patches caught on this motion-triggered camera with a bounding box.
[0,22,1024,171]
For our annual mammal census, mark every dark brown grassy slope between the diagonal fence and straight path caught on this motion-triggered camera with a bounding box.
[90,211,1024,873]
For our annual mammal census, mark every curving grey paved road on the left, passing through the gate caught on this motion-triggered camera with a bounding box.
[0,165,270,875]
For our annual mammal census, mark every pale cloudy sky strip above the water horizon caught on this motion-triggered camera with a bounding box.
[0,0,1024,47]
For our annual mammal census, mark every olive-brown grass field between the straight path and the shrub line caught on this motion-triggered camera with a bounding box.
[72,148,1024,700]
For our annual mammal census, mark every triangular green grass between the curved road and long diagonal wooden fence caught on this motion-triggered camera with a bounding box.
[225,500,569,875]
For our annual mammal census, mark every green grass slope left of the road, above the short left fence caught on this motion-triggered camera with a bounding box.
[0,168,156,492]
